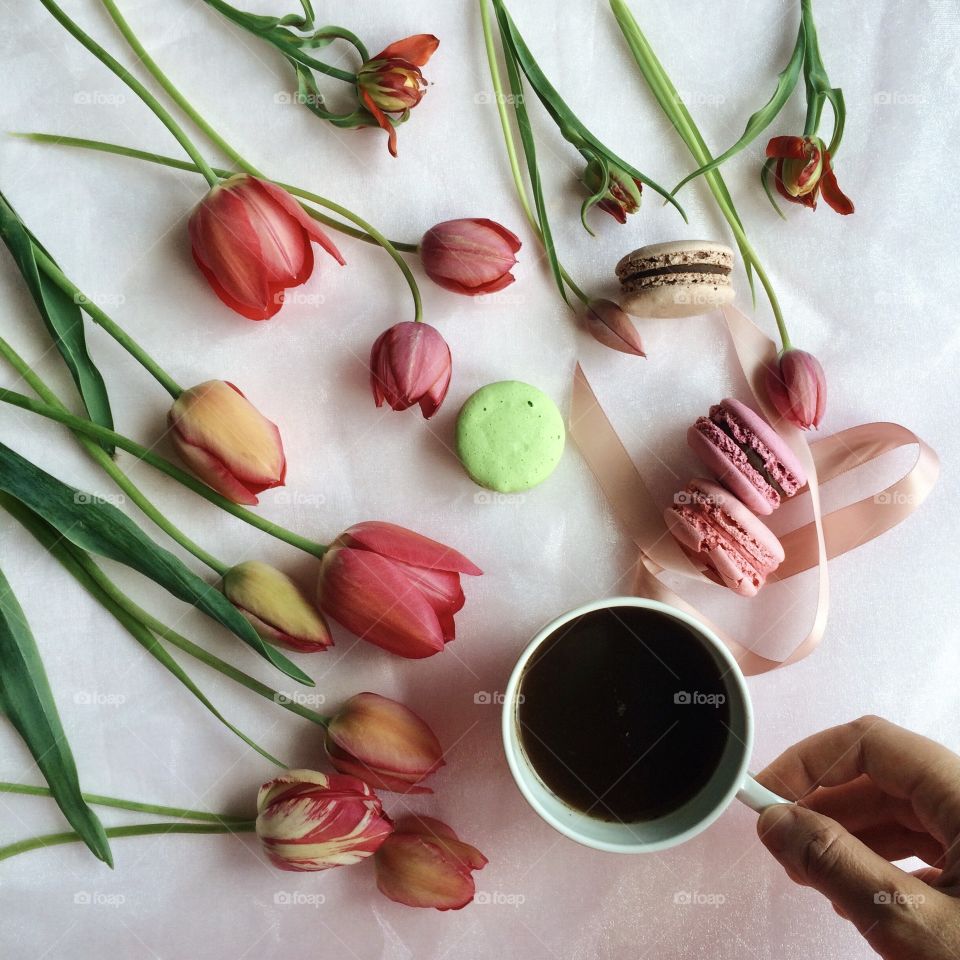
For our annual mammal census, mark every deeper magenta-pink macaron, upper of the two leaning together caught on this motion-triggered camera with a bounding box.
[687,398,807,516]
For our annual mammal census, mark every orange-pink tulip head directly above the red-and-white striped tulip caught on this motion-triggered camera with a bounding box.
[325,693,443,793]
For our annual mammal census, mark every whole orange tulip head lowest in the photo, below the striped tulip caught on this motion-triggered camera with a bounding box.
[374,816,487,910]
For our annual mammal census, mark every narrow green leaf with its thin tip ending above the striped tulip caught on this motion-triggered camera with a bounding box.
[0,494,286,767]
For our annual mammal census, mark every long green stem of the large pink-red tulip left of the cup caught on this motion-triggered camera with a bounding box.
[0,384,328,574]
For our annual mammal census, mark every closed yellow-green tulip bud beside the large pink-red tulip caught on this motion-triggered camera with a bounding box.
[223,560,333,653]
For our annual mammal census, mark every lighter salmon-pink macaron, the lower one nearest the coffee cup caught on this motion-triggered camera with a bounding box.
[663,479,784,597]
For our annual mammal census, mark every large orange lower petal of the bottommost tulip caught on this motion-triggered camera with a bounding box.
[375,834,476,910]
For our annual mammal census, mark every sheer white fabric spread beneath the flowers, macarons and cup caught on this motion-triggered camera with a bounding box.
[0,0,960,960]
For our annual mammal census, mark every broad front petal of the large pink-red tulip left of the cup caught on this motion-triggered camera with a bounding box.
[319,547,444,659]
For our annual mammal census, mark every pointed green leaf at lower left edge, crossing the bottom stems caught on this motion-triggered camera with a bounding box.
[0,570,113,867]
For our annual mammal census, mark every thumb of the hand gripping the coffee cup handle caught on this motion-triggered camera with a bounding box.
[757,804,931,939]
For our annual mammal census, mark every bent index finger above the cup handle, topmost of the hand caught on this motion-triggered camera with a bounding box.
[757,717,960,845]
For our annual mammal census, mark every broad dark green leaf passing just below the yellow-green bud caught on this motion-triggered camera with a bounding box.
[0,443,314,686]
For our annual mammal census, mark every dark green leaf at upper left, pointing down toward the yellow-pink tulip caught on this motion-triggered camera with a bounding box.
[0,193,114,456]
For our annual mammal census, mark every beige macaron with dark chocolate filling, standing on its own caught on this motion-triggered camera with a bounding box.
[616,240,735,317]
